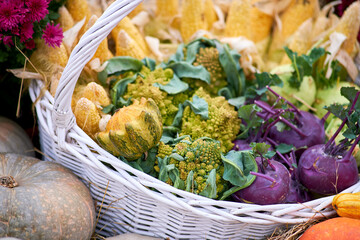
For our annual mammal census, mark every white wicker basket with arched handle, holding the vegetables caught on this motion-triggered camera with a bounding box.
[30,0,360,240]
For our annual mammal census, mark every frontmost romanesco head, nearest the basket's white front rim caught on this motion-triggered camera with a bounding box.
[155,137,226,198]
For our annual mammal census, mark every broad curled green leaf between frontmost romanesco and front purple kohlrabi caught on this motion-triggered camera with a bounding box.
[221,150,258,188]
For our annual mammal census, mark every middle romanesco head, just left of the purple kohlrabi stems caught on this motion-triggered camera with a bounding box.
[180,88,241,152]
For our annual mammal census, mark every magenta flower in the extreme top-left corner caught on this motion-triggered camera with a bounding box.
[0,0,27,31]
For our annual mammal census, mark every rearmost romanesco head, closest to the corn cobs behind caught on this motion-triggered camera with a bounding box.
[190,47,227,96]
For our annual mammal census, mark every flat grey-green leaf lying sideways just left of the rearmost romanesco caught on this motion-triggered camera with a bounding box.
[166,61,211,84]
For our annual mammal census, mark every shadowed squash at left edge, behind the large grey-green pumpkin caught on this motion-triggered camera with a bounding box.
[0,116,35,157]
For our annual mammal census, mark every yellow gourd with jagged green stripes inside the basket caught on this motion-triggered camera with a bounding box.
[95,98,162,160]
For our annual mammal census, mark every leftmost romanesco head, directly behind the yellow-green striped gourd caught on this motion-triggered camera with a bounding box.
[124,66,186,126]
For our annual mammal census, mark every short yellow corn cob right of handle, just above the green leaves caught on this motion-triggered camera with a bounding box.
[116,30,147,59]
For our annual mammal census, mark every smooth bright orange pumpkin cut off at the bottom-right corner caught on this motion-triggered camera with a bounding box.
[299,217,360,240]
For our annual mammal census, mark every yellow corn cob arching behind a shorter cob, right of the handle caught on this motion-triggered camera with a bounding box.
[111,16,150,55]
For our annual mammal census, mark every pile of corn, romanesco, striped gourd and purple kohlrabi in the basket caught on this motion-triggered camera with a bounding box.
[14,0,360,204]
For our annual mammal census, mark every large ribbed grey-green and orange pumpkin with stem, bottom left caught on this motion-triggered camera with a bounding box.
[0,153,96,240]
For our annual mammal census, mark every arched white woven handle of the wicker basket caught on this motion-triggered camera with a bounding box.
[52,0,142,149]
